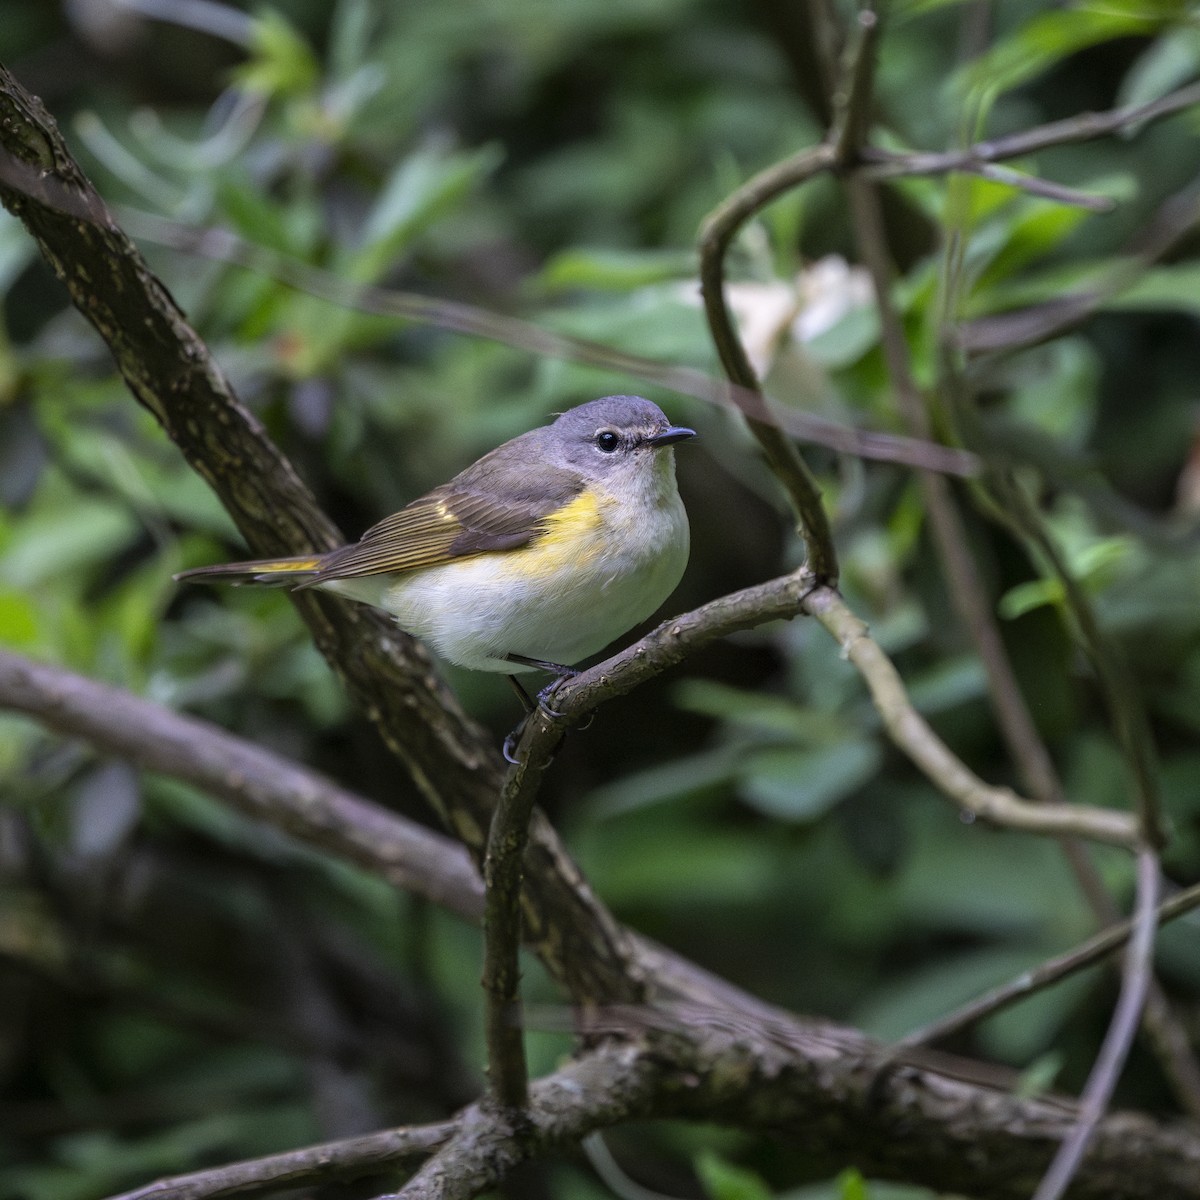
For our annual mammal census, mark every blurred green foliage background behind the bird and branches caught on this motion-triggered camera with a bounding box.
[0,0,1200,1200]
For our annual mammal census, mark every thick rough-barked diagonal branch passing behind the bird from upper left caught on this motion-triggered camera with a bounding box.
[0,58,637,1001]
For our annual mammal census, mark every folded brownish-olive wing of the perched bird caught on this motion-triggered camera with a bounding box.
[301,441,583,587]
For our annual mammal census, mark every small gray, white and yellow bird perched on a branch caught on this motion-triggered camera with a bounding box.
[182,396,696,704]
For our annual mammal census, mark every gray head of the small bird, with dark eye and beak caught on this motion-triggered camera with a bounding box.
[538,396,696,478]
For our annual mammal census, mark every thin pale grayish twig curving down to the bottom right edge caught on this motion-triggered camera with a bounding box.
[1033,847,1159,1200]
